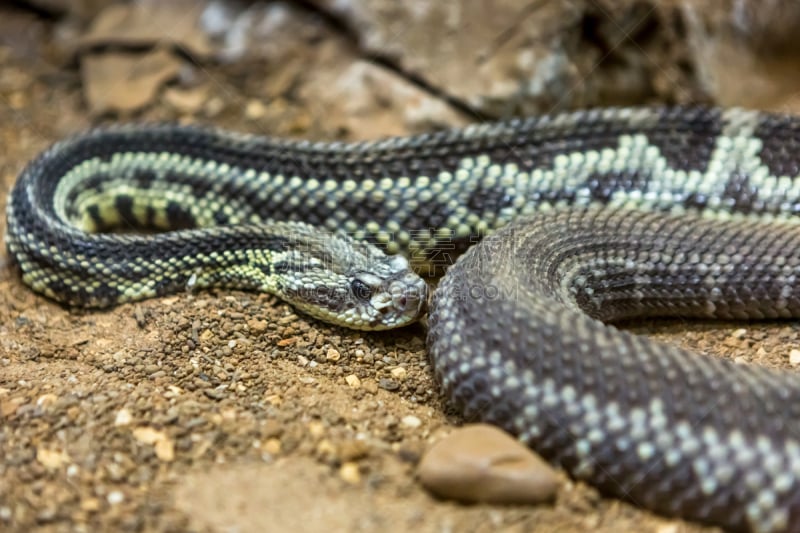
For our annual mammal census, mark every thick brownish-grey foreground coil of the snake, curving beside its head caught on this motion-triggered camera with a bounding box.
[428,208,800,531]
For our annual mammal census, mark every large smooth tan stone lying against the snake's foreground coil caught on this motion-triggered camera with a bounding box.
[418,424,558,504]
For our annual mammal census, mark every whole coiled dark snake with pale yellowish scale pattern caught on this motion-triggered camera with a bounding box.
[6,106,800,532]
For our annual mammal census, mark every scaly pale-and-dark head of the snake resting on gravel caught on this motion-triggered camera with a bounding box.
[275,223,428,330]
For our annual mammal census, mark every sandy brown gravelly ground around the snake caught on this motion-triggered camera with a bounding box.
[0,1,800,533]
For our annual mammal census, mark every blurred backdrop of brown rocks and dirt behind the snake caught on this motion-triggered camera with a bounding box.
[0,0,800,138]
